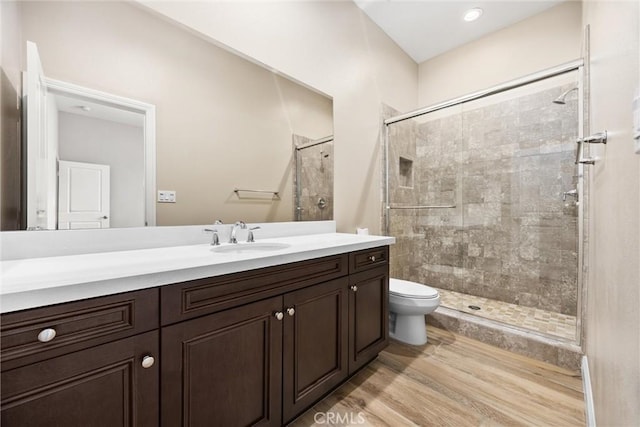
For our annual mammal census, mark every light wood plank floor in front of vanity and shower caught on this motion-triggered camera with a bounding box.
[292,325,585,427]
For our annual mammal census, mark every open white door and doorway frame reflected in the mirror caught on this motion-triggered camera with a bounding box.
[25,42,155,230]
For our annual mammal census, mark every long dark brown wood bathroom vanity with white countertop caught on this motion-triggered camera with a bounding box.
[1,234,393,427]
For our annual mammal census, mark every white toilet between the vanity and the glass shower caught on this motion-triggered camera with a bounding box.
[389,278,440,345]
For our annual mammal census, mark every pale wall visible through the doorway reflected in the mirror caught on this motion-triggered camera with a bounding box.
[58,112,145,228]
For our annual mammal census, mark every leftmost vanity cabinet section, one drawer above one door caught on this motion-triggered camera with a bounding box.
[0,289,160,427]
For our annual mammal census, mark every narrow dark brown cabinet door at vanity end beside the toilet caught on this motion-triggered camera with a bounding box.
[349,266,389,374]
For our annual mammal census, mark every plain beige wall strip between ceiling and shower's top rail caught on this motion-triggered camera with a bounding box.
[418,1,582,106]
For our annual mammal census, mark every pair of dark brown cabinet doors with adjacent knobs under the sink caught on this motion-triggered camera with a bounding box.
[161,277,349,427]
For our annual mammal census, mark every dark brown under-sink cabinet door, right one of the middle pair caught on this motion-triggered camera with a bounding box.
[283,278,349,422]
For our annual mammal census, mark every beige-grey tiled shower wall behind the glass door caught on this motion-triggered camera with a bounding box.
[383,85,578,315]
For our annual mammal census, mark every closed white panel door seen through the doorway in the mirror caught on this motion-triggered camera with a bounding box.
[58,160,110,230]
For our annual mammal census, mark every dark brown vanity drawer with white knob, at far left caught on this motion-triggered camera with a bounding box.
[0,289,159,371]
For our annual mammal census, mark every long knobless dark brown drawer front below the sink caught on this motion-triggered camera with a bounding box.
[160,254,349,325]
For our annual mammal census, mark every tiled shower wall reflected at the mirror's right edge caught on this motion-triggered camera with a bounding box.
[293,135,333,221]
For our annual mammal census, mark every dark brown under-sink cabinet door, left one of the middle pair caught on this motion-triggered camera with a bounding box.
[161,297,282,427]
